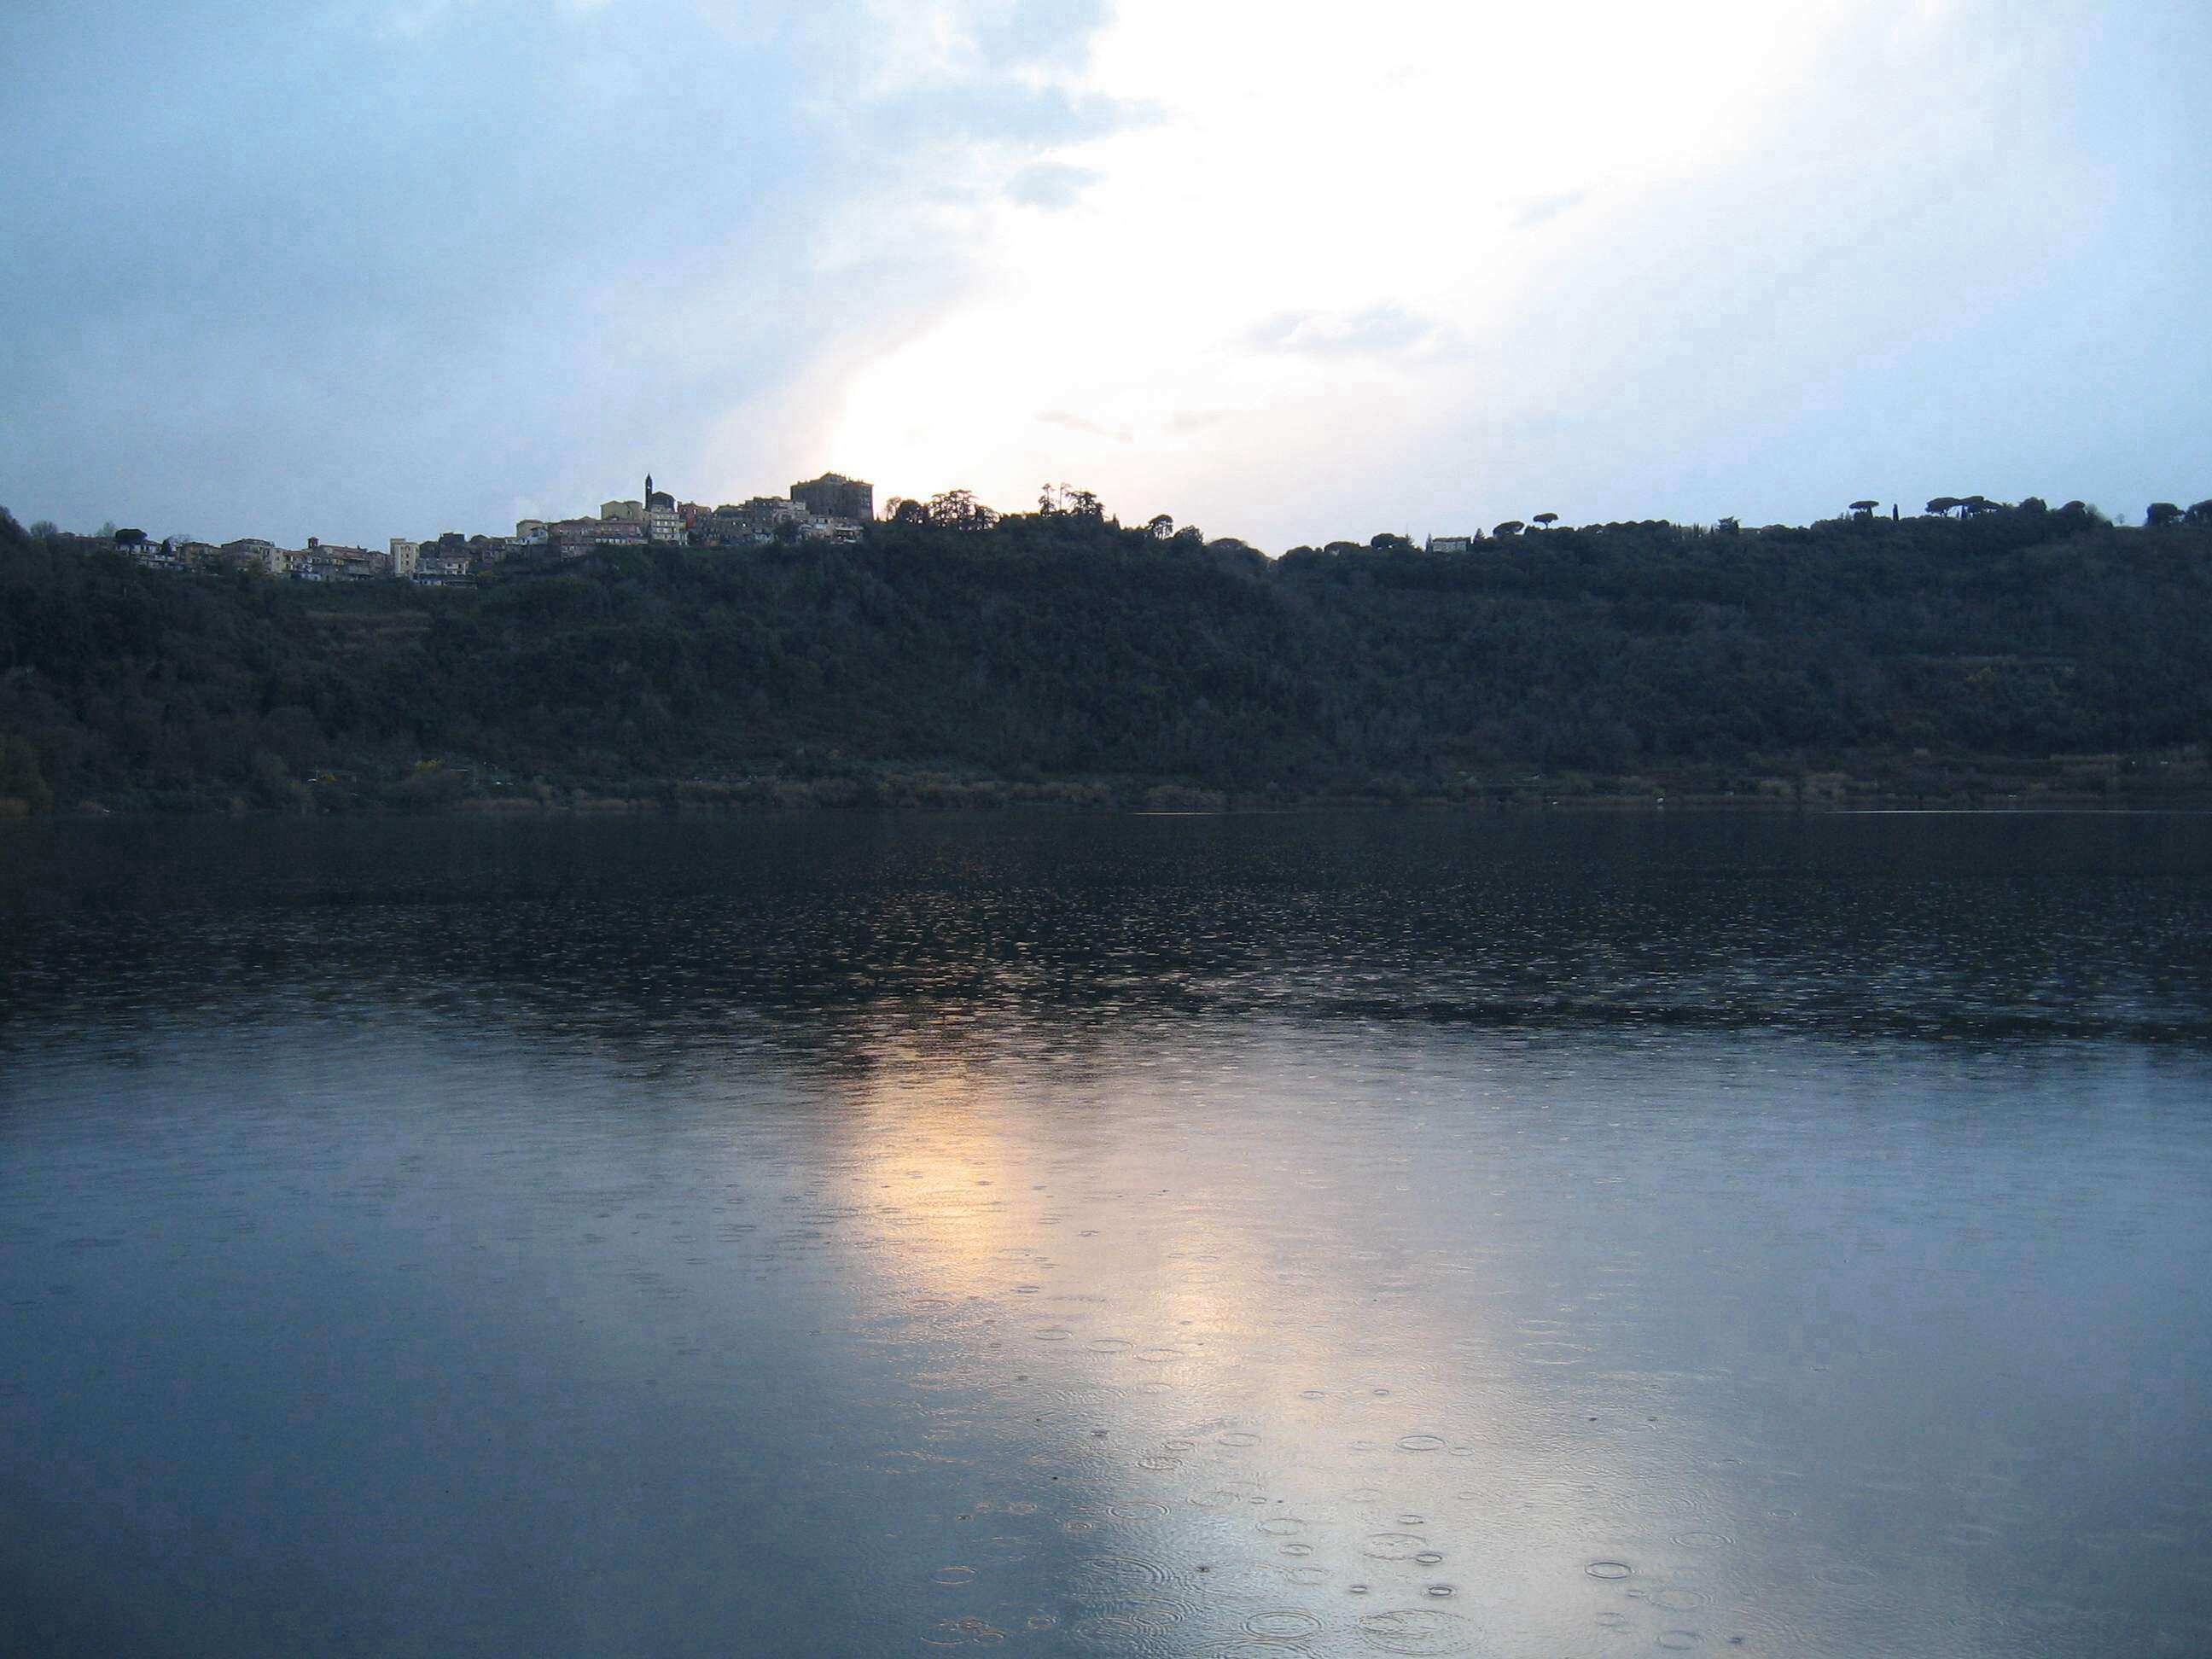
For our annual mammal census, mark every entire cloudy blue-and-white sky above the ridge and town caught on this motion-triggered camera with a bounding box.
[0,0,2212,553]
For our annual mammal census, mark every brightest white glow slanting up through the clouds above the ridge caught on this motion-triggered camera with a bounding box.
[838,0,1842,520]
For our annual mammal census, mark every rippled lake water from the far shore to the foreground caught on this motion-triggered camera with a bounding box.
[0,816,2212,1659]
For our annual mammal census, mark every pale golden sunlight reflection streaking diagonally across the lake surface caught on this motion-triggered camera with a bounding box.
[823,1027,2000,1644]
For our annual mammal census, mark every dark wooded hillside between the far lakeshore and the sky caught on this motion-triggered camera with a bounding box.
[0,498,2212,810]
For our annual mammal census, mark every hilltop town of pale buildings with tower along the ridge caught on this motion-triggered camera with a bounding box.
[97,474,876,588]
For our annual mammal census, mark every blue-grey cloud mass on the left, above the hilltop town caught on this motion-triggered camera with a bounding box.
[0,0,1117,542]
